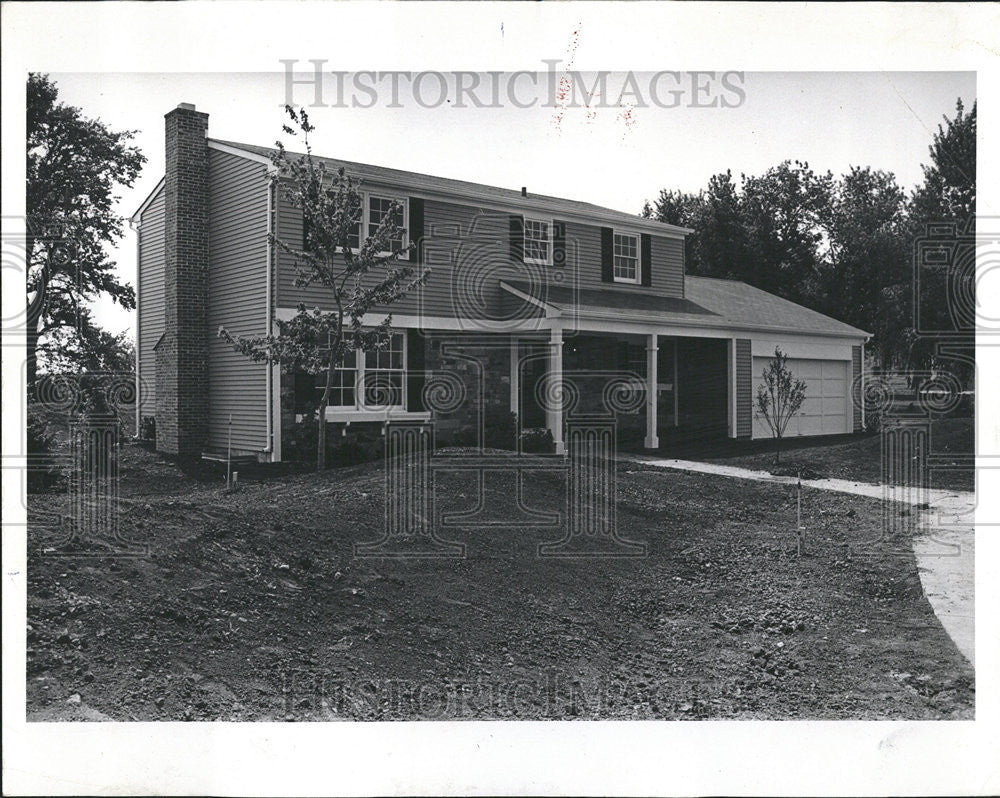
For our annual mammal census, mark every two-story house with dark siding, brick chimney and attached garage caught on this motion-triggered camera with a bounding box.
[132,104,869,462]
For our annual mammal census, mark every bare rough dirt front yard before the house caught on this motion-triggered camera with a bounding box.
[27,447,974,721]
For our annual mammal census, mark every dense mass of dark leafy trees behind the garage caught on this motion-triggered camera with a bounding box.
[647,96,976,381]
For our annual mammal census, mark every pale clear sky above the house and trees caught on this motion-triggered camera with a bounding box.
[50,69,976,340]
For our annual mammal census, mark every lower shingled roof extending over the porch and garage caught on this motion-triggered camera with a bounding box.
[500,276,869,338]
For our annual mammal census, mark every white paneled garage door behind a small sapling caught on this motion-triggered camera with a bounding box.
[753,357,851,438]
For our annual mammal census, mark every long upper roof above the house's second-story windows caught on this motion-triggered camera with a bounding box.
[203,139,693,238]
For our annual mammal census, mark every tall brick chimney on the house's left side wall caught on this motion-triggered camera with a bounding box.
[156,103,208,457]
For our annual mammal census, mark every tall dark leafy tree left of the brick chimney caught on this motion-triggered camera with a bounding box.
[25,73,146,396]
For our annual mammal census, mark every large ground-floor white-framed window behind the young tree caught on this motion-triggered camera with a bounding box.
[316,332,406,410]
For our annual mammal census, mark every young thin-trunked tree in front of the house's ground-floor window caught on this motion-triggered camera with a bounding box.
[219,105,430,471]
